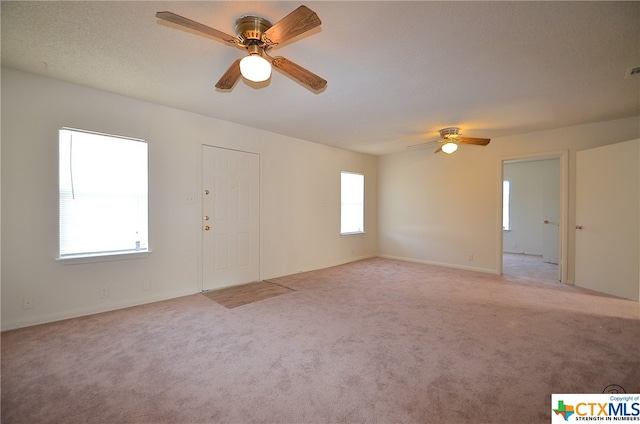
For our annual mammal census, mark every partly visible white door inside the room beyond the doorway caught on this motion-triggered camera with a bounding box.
[542,159,560,264]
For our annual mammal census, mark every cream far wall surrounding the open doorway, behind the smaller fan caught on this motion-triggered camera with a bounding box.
[378,117,640,283]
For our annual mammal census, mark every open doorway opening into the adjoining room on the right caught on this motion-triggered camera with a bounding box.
[501,155,564,284]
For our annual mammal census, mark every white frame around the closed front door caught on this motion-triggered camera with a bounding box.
[196,143,263,292]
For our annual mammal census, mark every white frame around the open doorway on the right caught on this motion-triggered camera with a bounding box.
[496,150,569,283]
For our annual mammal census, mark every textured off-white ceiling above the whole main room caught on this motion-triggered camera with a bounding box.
[2,1,640,154]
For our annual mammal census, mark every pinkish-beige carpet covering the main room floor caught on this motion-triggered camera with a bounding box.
[2,259,640,424]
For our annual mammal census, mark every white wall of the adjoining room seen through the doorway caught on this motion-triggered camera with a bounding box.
[502,159,560,255]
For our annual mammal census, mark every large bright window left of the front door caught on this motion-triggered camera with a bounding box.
[58,128,149,259]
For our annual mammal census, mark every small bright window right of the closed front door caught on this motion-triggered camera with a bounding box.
[340,172,364,234]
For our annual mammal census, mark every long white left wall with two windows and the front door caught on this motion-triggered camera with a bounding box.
[1,69,377,329]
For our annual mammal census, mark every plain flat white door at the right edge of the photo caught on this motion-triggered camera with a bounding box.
[575,140,640,300]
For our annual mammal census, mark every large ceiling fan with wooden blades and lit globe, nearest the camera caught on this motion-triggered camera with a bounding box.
[156,6,327,91]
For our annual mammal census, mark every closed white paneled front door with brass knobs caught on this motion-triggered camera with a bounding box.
[202,146,260,290]
